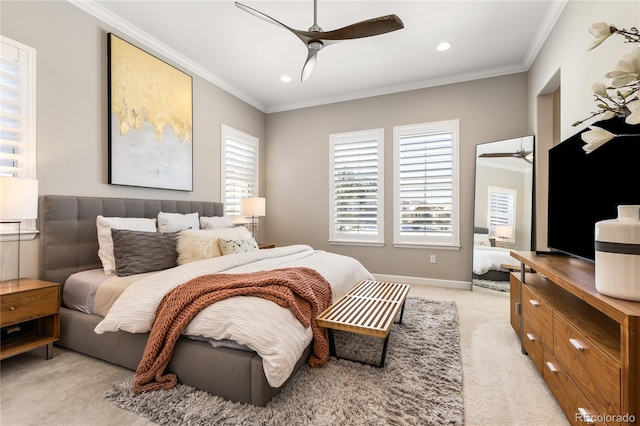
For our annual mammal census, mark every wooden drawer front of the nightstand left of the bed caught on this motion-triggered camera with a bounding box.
[0,286,60,327]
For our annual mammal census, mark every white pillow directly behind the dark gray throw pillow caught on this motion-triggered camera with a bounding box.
[96,215,156,274]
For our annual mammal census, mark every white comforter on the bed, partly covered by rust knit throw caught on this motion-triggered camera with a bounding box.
[95,245,373,387]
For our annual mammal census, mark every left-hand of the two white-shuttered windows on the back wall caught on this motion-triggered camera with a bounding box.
[329,129,384,245]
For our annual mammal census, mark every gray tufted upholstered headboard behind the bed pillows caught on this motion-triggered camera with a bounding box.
[38,195,224,283]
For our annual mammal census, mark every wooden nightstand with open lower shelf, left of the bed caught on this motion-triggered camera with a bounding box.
[0,278,60,359]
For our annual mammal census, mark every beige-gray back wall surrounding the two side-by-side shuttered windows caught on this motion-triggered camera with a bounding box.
[263,73,528,282]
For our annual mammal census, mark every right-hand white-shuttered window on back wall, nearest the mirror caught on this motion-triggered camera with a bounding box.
[393,120,460,249]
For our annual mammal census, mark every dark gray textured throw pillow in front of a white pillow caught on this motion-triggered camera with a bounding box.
[111,229,178,277]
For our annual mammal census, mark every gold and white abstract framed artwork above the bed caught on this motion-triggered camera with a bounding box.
[107,33,193,191]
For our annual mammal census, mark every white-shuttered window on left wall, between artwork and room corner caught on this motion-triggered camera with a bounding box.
[221,125,258,216]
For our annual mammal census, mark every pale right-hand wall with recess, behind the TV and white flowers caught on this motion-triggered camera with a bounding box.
[528,0,640,250]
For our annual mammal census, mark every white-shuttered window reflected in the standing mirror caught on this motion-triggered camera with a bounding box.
[487,186,518,244]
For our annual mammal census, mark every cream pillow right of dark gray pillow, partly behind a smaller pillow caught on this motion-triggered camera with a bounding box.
[176,226,251,265]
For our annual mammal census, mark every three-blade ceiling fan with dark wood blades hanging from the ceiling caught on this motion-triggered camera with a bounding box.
[236,0,404,81]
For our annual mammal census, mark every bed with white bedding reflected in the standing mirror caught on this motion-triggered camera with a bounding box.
[473,227,514,281]
